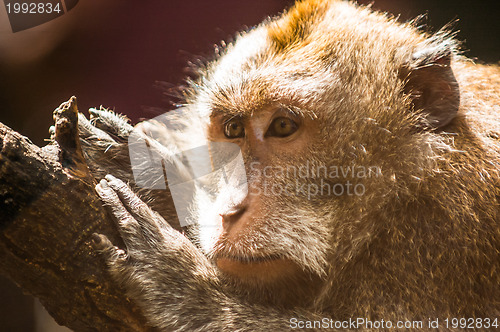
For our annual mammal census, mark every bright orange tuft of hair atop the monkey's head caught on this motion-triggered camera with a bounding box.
[268,0,329,52]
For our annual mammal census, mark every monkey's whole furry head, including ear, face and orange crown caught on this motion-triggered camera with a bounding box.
[188,0,459,300]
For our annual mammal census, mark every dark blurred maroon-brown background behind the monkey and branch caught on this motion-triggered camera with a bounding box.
[0,0,500,332]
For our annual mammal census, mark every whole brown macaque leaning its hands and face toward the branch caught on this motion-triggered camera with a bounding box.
[88,0,500,331]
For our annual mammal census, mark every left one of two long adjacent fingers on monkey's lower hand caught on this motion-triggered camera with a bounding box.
[95,180,141,239]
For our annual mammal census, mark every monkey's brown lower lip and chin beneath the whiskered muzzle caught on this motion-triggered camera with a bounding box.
[217,258,301,283]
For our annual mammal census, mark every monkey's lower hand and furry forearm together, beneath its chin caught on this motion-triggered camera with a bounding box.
[94,175,321,331]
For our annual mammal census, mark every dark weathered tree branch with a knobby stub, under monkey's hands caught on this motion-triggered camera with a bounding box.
[0,97,151,331]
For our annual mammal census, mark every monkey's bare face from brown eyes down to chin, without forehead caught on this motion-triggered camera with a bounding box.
[203,103,336,283]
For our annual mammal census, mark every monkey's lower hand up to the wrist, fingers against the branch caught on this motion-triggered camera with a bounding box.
[93,175,225,330]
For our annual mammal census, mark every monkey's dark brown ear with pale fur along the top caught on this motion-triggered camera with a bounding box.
[401,47,460,129]
